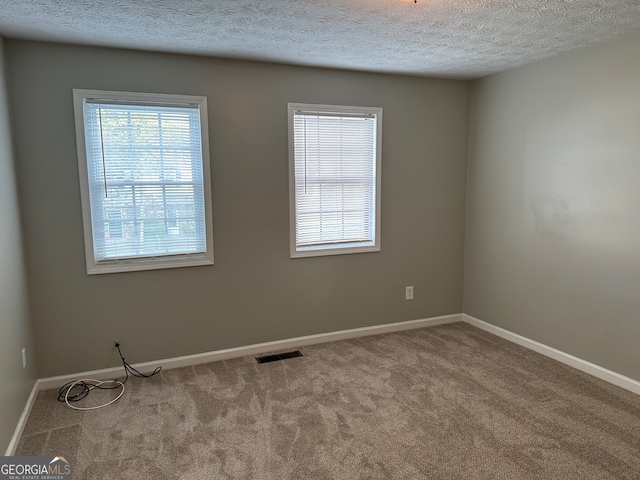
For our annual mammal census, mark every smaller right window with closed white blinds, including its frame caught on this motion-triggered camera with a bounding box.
[289,103,382,258]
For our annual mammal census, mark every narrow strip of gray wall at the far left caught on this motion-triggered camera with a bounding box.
[0,37,36,455]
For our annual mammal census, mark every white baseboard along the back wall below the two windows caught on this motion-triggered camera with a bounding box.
[38,313,462,390]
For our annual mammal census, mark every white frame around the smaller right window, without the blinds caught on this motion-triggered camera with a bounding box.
[287,103,382,258]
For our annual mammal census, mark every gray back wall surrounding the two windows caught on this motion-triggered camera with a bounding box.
[7,41,469,377]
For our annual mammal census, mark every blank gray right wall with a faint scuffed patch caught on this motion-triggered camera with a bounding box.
[464,33,640,380]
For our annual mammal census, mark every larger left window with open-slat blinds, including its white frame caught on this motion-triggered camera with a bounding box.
[73,90,213,274]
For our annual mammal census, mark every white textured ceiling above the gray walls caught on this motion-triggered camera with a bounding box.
[0,0,640,78]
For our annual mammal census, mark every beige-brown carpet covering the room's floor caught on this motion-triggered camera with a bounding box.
[16,323,640,480]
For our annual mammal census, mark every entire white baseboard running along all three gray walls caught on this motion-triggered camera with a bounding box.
[5,313,640,456]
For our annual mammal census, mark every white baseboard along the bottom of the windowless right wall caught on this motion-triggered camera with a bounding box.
[462,313,640,394]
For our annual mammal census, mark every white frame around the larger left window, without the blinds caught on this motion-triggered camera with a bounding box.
[73,89,213,275]
